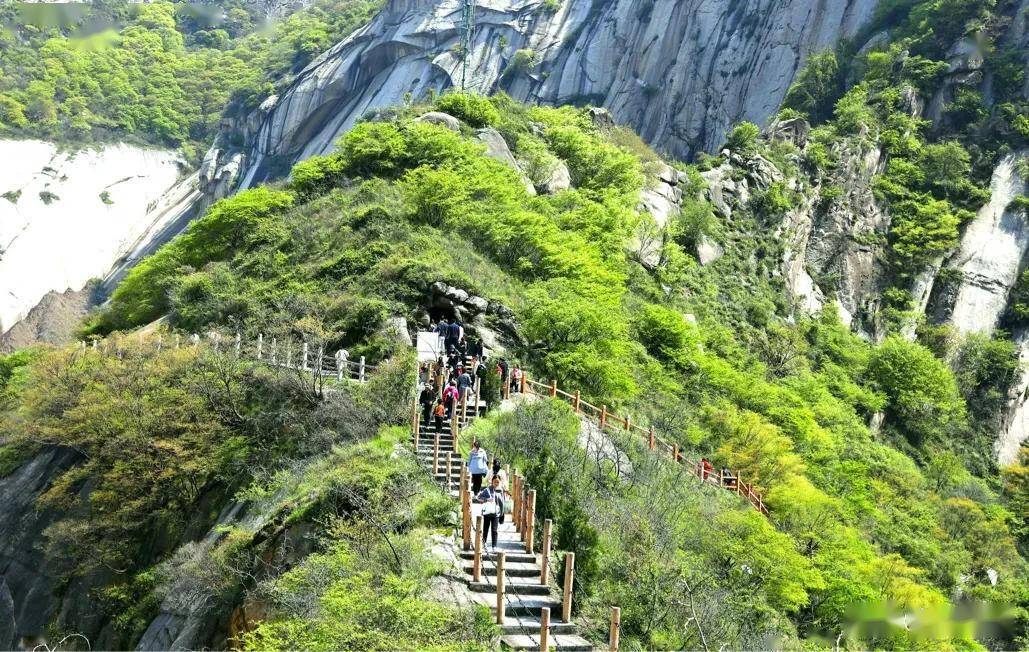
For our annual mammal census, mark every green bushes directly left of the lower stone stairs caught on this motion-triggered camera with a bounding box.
[242,429,495,651]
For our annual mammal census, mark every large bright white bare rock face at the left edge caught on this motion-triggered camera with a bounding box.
[0,140,181,332]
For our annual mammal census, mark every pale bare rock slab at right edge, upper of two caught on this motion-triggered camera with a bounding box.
[949,154,1029,332]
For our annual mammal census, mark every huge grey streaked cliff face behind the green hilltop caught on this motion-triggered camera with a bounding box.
[231,0,876,186]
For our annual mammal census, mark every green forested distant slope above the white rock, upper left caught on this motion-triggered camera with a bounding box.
[0,0,381,161]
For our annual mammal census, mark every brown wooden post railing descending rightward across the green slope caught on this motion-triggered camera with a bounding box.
[521,370,769,516]
